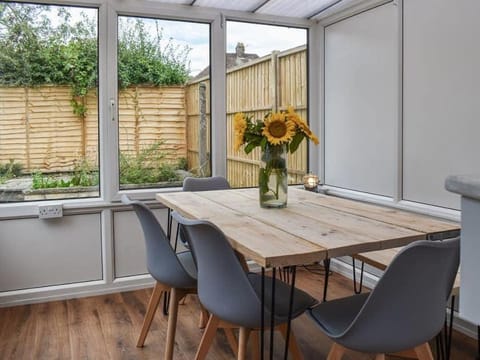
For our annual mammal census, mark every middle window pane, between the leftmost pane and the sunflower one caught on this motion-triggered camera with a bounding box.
[118,16,210,189]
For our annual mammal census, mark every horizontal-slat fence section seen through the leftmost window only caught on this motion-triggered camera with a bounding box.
[0,86,98,171]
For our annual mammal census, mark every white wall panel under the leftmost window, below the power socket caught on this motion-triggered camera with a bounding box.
[0,213,103,293]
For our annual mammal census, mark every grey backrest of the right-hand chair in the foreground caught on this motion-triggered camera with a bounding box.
[338,238,460,353]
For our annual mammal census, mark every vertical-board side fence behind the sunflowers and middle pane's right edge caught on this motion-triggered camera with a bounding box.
[186,46,307,187]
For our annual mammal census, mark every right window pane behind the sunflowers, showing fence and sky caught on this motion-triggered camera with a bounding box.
[226,21,308,187]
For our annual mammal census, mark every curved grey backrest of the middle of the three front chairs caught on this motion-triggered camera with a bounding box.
[172,211,270,328]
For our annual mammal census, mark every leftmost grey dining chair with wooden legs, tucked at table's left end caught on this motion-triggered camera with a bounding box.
[122,195,197,359]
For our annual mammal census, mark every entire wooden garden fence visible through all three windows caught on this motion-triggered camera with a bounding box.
[0,47,307,187]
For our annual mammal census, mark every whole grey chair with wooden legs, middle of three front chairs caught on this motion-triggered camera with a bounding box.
[172,211,316,359]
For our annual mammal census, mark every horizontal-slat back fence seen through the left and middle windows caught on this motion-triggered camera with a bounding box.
[0,86,187,172]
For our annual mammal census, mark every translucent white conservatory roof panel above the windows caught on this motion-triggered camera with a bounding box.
[152,0,359,20]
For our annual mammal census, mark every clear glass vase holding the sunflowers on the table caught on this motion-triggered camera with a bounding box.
[258,145,288,208]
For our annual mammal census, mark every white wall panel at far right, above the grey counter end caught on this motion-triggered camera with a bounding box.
[403,0,480,209]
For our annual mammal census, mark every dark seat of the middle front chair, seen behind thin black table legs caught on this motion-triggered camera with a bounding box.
[248,273,317,322]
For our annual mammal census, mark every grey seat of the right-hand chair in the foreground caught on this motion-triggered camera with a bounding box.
[308,293,370,338]
